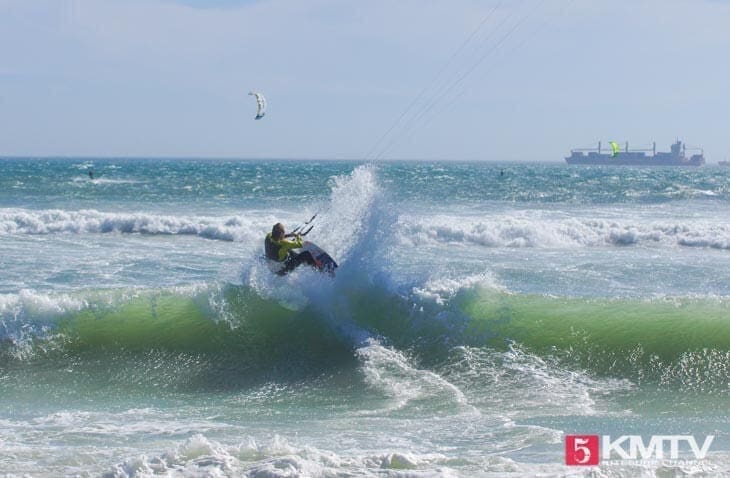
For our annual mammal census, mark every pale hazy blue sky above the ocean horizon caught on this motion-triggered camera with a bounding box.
[0,0,730,162]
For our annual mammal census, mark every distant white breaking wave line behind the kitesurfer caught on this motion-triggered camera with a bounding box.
[5,206,730,253]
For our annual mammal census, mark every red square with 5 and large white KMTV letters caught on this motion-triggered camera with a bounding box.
[565,435,715,466]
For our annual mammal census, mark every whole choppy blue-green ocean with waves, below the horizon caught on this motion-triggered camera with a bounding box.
[0,158,730,477]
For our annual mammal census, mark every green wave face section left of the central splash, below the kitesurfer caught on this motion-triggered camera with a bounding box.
[0,286,354,394]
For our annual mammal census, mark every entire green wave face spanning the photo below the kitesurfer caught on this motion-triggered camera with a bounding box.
[5,285,730,389]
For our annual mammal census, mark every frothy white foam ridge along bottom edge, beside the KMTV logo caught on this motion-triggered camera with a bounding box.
[104,434,728,478]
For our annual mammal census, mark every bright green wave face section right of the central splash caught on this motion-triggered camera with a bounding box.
[458,290,730,388]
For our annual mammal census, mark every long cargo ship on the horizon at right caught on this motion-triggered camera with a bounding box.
[565,140,705,166]
